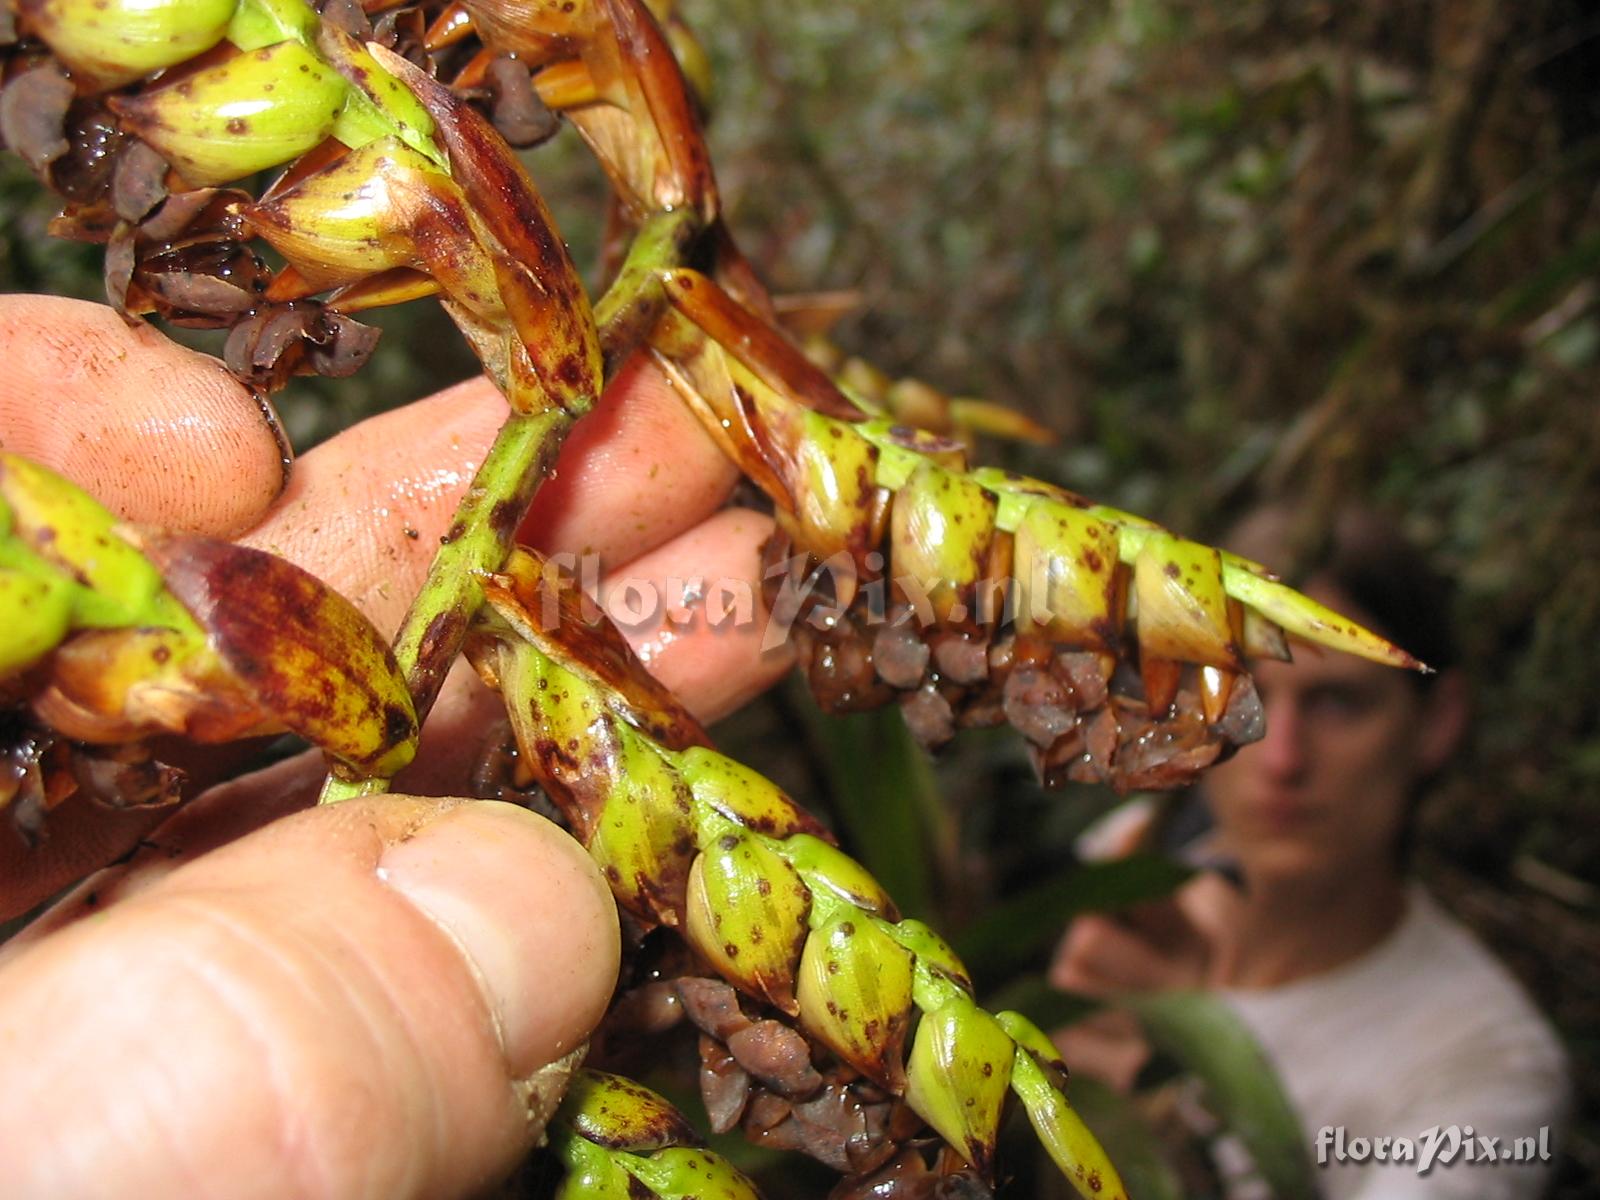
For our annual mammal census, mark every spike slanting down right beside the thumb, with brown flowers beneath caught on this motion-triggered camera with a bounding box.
[469,550,1115,1194]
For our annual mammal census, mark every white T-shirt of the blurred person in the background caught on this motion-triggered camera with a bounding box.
[1221,888,1568,1200]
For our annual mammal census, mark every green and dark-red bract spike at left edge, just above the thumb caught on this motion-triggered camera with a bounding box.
[0,453,416,771]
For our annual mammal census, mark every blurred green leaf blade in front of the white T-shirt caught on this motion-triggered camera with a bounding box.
[1118,992,1317,1200]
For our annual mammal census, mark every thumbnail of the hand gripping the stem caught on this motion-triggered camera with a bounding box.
[378,800,619,1080]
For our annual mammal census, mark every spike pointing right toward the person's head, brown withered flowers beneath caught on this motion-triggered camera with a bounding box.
[651,270,1418,789]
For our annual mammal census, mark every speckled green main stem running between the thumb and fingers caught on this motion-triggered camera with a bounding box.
[318,211,699,805]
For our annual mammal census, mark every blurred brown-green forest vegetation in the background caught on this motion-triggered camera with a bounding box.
[0,0,1600,1197]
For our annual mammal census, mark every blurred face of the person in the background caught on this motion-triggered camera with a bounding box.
[1205,582,1464,882]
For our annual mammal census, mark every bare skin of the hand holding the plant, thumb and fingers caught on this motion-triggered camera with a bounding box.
[0,296,789,1197]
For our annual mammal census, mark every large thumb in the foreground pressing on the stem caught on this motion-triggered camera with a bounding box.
[0,797,618,1198]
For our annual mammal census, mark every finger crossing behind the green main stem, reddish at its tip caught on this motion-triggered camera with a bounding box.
[235,360,738,632]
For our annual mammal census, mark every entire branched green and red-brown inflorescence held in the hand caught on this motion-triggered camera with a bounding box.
[0,0,1419,1197]
